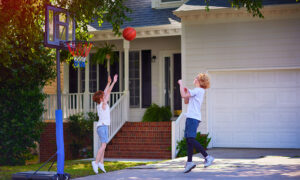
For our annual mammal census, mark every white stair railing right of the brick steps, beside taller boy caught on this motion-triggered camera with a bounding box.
[172,113,185,159]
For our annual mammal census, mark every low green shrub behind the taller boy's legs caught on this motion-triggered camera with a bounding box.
[176,132,211,157]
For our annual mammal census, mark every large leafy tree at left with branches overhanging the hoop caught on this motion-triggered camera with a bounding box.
[0,0,130,165]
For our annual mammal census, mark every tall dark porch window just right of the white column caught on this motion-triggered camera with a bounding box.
[129,51,140,108]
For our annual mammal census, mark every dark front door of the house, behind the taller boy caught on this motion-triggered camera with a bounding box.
[173,53,182,111]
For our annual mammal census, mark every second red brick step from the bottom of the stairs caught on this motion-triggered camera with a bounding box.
[106,144,171,152]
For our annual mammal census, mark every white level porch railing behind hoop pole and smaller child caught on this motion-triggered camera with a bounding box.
[43,92,123,120]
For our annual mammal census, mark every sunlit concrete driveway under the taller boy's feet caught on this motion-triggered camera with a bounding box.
[74,148,300,180]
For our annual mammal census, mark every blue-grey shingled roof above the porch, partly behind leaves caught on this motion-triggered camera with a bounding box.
[90,0,180,30]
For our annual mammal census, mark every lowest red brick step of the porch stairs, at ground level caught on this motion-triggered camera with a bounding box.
[105,151,171,159]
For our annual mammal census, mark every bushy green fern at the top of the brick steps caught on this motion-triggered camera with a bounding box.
[143,104,172,122]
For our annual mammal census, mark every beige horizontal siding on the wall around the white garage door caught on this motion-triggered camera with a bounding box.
[182,19,300,133]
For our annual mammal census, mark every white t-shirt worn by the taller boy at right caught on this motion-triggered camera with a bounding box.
[186,87,205,121]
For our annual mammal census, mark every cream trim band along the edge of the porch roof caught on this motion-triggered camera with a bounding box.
[90,22,181,41]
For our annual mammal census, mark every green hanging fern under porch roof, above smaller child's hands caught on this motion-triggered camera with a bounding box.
[91,42,116,77]
